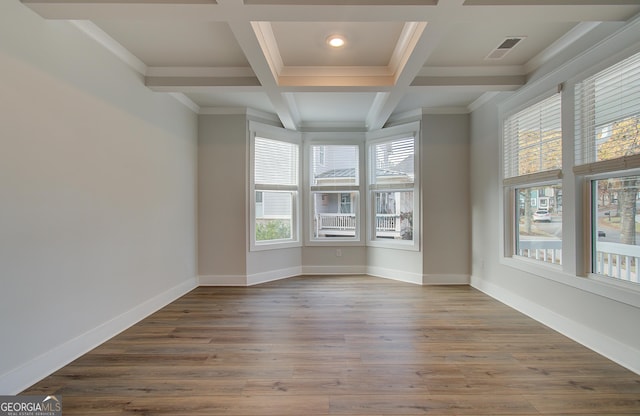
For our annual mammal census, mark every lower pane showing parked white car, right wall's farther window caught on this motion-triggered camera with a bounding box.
[516,183,562,264]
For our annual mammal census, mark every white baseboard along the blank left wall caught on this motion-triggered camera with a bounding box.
[0,278,198,395]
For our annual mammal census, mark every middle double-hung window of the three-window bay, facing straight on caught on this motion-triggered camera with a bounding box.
[309,142,360,241]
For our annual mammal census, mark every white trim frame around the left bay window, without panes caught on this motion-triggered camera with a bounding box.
[247,120,302,251]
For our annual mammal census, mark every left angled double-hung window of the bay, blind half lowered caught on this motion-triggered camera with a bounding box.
[250,122,300,249]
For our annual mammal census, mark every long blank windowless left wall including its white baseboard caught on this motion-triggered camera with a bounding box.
[0,0,197,394]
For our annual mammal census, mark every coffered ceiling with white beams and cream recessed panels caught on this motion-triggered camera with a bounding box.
[22,0,640,130]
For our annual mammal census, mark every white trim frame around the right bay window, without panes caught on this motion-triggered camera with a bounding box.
[365,121,422,251]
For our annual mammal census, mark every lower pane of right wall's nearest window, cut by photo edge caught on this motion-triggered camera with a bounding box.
[592,176,640,283]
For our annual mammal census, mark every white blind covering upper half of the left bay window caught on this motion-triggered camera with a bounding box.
[254,137,299,189]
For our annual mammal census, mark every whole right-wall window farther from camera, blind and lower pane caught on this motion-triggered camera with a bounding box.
[503,92,562,264]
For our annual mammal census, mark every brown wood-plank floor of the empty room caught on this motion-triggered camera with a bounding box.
[23,276,640,416]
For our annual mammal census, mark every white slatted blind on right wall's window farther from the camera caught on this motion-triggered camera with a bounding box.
[503,93,562,183]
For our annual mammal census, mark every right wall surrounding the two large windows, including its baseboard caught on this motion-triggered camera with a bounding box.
[470,19,640,373]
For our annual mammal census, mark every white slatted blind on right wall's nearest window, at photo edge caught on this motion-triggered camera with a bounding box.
[574,54,640,174]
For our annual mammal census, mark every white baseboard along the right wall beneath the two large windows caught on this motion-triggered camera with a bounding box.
[471,276,640,374]
